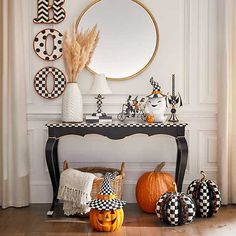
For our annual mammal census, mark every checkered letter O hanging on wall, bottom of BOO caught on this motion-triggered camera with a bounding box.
[34,67,66,99]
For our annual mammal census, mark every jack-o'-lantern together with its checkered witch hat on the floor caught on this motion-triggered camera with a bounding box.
[87,172,126,232]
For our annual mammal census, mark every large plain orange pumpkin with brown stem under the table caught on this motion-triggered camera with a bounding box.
[136,162,175,213]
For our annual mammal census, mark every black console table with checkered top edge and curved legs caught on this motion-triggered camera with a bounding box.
[46,123,188,216]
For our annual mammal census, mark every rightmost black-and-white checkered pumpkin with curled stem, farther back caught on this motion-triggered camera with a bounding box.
[187,171,221,217]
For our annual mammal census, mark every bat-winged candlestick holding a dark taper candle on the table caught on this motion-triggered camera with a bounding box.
[168,74,183,122]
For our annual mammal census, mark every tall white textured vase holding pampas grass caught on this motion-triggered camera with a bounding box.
[62,83,83,122]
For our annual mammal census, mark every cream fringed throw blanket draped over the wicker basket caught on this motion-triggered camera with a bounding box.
[57,168,96,216]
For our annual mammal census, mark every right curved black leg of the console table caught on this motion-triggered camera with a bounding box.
[175,137,188,192]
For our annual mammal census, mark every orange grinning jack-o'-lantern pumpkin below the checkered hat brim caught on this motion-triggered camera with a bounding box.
[89,208,124,232]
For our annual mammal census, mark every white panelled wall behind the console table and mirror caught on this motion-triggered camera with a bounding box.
[24,0,218,202]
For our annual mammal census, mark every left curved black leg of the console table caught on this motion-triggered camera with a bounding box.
[45,138,60,216]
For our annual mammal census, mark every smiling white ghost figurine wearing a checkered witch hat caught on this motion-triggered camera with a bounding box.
[145,77,167,122]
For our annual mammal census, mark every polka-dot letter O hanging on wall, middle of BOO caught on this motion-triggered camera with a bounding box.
[33,29,63,61]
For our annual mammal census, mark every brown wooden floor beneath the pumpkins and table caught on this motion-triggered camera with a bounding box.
[0,204,236,236]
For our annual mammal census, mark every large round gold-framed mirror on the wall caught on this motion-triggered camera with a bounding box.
[77,0,158,80]
